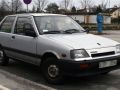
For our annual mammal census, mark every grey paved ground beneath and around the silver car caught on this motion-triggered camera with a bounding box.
[0,31,120,90]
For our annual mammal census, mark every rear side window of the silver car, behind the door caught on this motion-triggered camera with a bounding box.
[0,16,15,33]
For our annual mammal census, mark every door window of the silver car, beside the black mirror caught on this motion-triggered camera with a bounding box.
[14,17,34,36]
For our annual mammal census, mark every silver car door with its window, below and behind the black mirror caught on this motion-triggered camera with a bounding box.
[10,16,37,64]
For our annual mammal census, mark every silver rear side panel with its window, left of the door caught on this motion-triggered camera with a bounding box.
[0,16,16,55]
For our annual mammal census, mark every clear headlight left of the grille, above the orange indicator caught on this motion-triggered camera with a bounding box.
[70,49,89,59]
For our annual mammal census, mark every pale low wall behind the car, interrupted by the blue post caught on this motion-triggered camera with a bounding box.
[69,15,111,24]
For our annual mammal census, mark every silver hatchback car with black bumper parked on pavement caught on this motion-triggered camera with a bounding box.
[0,14,120,84]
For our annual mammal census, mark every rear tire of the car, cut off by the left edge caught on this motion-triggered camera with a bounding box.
[0,48,9,66]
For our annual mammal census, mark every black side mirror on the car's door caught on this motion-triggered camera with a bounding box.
[23,23,36,37]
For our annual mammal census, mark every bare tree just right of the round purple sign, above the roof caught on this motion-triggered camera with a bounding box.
[35,0,48,12]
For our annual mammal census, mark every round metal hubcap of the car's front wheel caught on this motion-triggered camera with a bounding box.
[48,65,59,78]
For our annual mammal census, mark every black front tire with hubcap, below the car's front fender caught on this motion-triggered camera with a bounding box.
[41,57,63,84]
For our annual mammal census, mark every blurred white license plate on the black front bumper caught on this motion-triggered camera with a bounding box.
[99,60,117,68]
